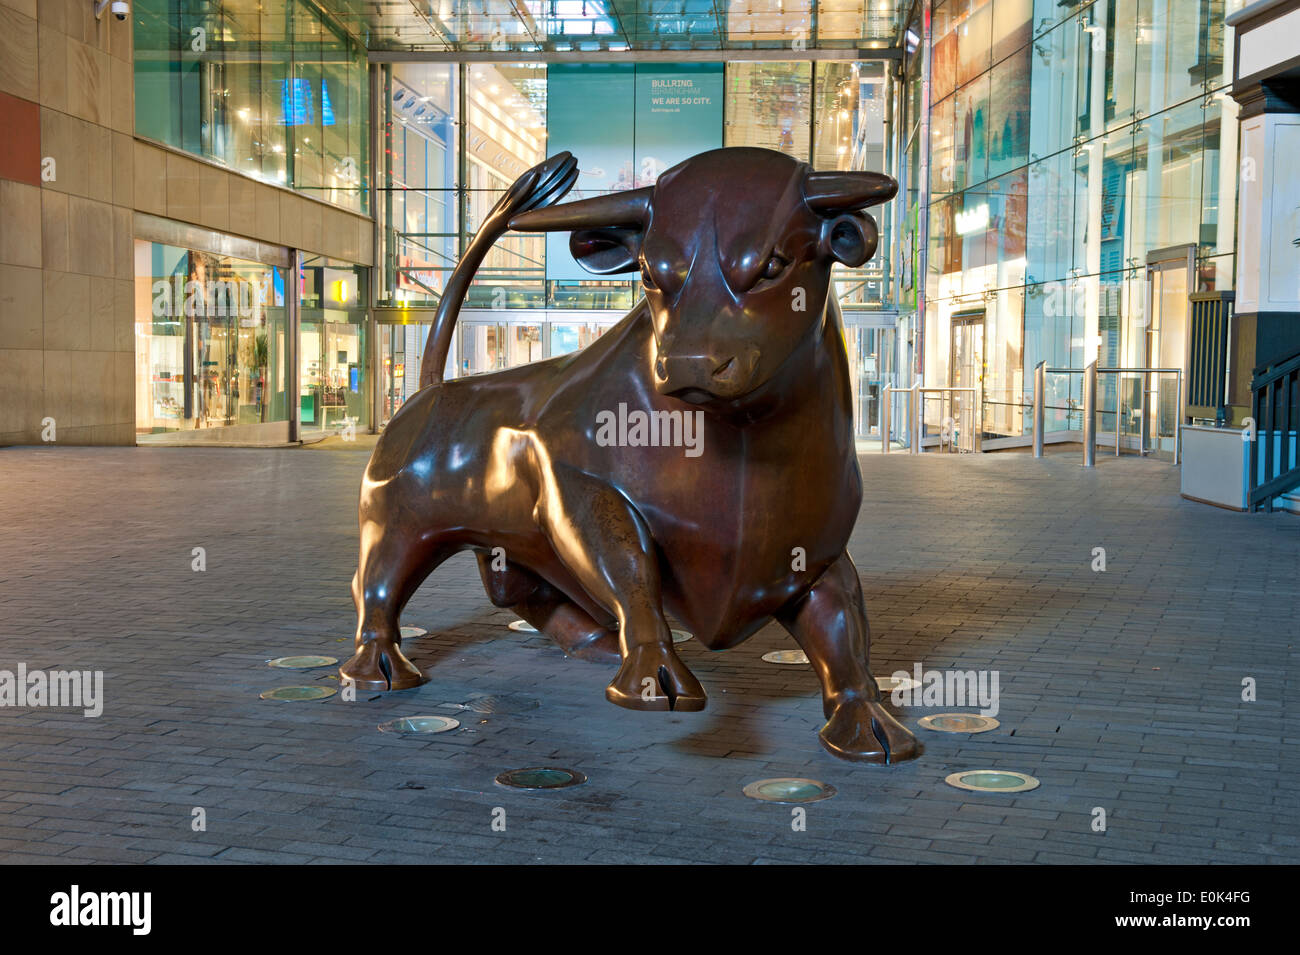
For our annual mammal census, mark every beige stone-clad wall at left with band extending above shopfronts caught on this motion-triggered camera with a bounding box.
[0,0,372,446]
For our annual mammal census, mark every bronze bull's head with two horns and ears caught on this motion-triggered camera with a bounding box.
[510,148,898,403]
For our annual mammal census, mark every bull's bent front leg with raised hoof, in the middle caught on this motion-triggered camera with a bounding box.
[537,464,707,709]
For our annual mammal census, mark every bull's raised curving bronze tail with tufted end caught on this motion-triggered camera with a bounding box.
[420,152,577,388]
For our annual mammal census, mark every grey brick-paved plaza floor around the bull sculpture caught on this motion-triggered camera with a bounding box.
[0,448,1300,864]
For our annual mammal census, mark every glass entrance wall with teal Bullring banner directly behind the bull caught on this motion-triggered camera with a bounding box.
[376,60,894,427]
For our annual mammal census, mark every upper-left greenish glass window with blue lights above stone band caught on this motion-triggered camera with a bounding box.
[131,0,369,212]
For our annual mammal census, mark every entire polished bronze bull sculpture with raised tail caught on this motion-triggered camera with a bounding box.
[339,148,917,763]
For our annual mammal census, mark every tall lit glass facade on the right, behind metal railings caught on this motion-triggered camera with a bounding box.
[897,0,1238,439]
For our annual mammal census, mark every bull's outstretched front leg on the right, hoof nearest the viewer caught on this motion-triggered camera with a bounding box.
[776,551,918,763]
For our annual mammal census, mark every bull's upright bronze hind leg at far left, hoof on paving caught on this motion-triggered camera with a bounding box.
[338,521,456,690]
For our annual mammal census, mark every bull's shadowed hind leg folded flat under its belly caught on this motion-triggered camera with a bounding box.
[478,551,621,663]
